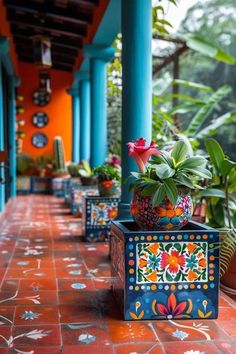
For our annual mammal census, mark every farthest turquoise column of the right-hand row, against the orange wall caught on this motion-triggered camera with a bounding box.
[67,89,80,163]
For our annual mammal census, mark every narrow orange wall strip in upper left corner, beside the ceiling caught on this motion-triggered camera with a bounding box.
[0,0,18,75]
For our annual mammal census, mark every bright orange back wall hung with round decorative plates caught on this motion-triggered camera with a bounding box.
[17,62,72,161]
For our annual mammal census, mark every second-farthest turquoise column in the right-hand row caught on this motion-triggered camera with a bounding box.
[76,71,91,161]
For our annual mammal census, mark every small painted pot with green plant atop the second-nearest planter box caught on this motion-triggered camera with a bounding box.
[94,164,120,197]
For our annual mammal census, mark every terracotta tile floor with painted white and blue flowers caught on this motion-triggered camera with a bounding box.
[0,195,236,354]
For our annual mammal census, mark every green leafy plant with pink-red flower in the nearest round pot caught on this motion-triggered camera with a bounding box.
[128,138,211,207]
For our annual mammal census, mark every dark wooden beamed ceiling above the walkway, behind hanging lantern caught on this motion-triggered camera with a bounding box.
[4,0,100,72]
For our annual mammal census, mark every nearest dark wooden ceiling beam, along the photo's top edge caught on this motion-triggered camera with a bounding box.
[4,0,92,25]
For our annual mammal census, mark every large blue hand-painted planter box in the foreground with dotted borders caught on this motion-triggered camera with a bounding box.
[110,220,219,320]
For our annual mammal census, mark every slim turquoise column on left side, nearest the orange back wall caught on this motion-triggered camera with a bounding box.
[9,75,16,198]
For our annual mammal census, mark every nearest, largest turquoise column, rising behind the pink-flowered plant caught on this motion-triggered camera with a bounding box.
[119,0,152,218]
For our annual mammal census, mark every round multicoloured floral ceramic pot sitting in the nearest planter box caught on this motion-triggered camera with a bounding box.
[130,190,193,231]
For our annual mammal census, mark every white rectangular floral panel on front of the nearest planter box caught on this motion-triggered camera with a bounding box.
[136,242,208,283]
